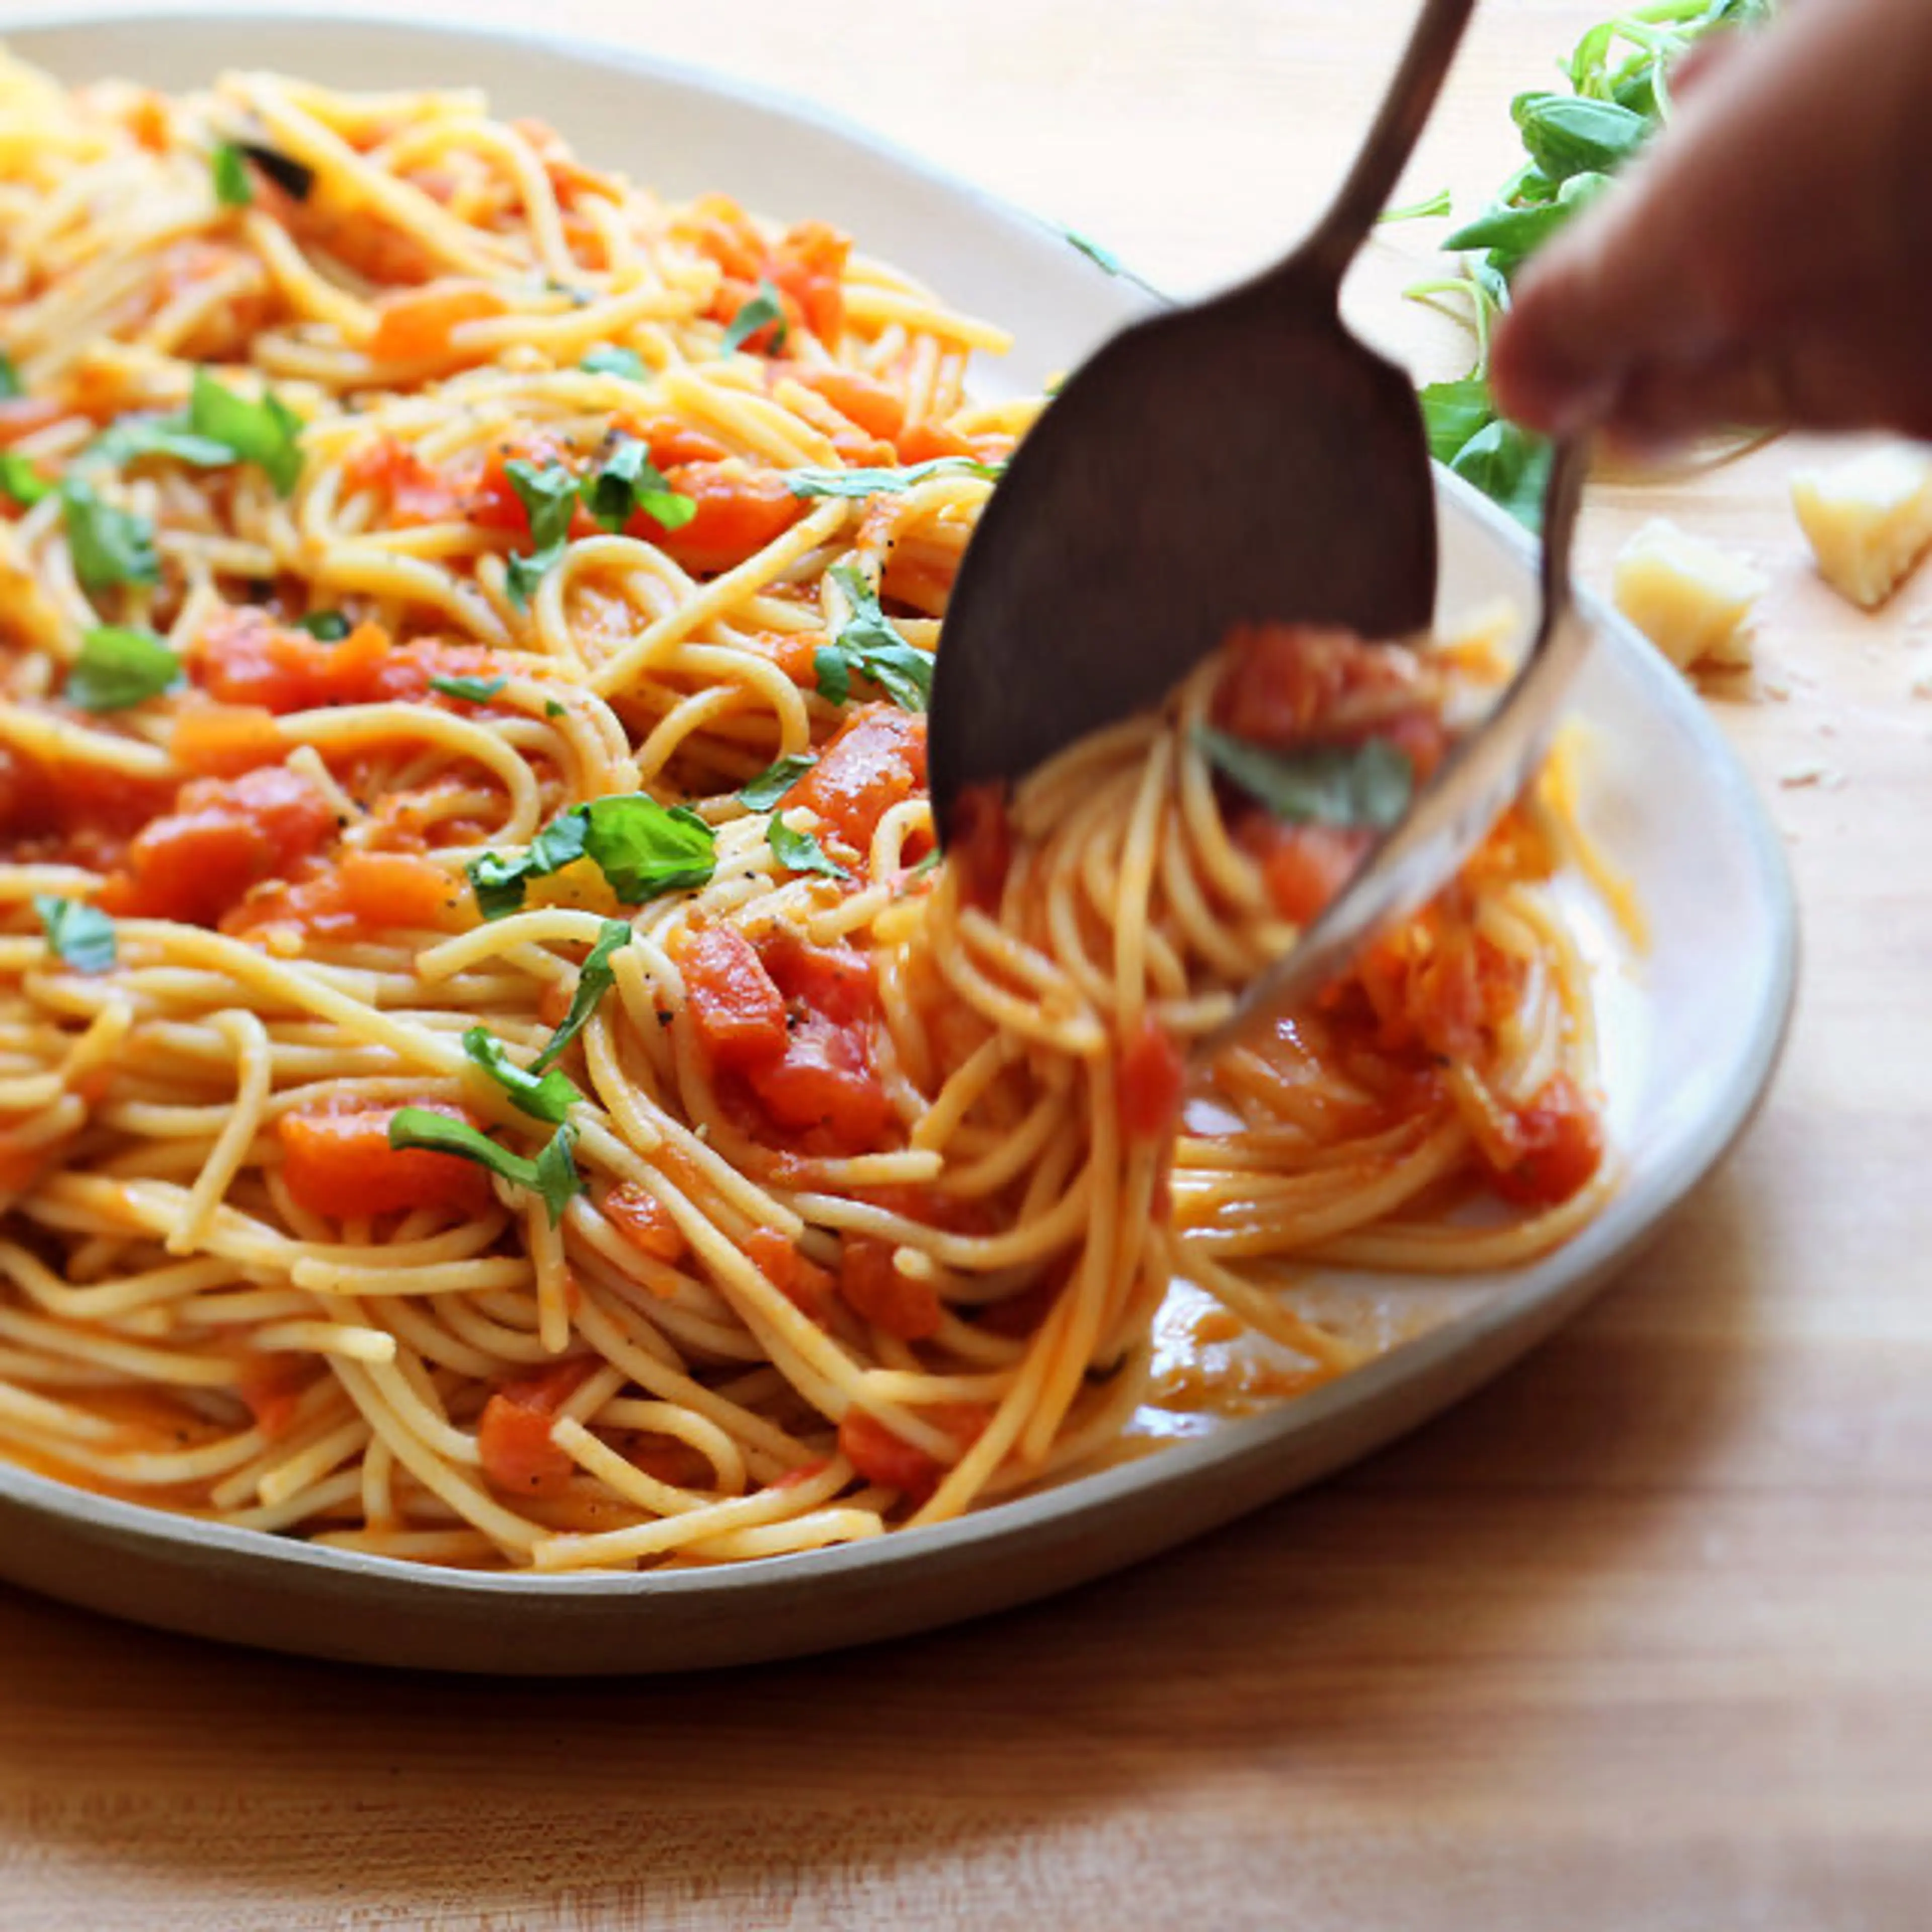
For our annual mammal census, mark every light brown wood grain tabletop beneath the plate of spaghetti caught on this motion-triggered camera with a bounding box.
[0,0,1932,1932]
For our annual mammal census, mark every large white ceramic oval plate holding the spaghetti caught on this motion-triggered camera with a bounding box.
[0,14,1795,1673]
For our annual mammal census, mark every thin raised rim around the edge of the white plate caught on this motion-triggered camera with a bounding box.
[0,11,1799,1646]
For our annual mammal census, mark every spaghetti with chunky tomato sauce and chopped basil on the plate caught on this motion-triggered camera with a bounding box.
[0,62,1607,1571]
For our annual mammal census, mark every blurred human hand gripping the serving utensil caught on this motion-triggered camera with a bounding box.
[1490,0,1932,444]
